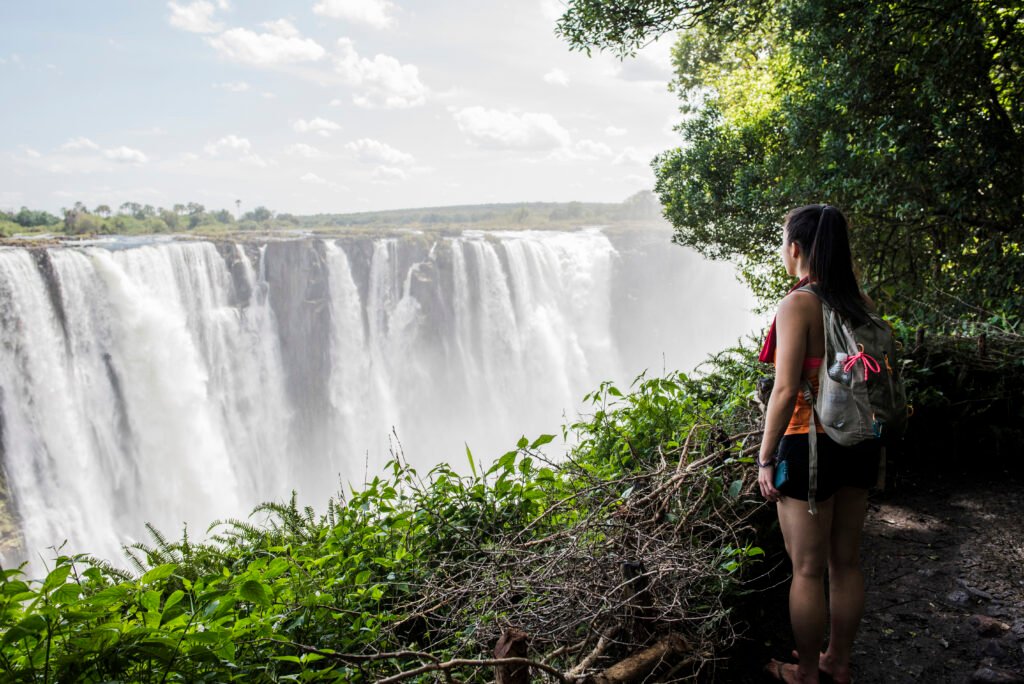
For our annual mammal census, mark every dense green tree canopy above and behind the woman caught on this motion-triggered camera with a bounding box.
[558,0,1024,320]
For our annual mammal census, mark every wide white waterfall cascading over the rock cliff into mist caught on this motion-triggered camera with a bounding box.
[0,229,753,563]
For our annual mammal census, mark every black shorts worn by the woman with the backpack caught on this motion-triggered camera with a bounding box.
[776,432,881,501]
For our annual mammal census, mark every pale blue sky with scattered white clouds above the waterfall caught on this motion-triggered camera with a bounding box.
[0,0,681,214]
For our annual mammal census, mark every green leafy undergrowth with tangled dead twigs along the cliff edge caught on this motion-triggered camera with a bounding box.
[0,350,761,682]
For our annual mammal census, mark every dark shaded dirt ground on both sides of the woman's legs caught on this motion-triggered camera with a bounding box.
[711,462,1024,684]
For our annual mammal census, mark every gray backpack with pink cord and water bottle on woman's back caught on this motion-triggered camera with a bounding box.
[800,285,907,514]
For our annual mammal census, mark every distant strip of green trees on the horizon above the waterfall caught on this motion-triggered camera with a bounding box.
[0,190,660,236]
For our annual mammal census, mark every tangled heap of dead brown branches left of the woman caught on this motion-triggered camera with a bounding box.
[364,426,759,682]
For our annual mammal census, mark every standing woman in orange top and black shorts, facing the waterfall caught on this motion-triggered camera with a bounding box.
[758,205,879,682]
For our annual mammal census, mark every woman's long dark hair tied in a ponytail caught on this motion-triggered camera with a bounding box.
[785,204,870,326]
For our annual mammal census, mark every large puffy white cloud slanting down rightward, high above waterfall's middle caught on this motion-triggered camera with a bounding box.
[335,38,427,109]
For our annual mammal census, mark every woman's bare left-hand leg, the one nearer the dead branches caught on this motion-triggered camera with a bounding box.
[778,498,834,682]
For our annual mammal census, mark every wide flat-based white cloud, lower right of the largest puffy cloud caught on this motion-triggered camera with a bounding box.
[453,106,570,149]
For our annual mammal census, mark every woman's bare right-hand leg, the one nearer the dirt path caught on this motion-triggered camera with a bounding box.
[821,487,867,682]
